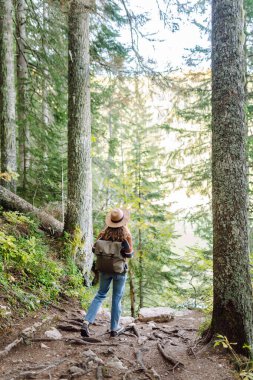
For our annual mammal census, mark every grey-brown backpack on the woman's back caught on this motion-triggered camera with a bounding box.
[94,240,126,273]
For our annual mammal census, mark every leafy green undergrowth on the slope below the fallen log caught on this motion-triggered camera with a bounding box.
[0,211,91,326]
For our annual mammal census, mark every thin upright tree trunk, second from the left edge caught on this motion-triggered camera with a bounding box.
[16,0,31,192]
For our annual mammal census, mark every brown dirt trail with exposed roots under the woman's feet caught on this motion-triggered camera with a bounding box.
[0,301,235,380]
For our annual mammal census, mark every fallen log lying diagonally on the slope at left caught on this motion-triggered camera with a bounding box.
[0,186,63,236]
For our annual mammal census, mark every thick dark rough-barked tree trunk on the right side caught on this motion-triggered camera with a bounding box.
[212,0,253,351]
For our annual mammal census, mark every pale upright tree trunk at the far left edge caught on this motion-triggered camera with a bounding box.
[0,0,17,191]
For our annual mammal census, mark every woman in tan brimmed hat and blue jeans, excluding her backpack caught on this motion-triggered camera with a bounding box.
[81,208,133,337]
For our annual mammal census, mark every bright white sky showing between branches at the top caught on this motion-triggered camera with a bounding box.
[119,0,211,71]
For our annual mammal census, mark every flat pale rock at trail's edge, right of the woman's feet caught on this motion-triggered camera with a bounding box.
[138,307,175,322]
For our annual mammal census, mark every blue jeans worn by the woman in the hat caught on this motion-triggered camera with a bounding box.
[85,273,126,331]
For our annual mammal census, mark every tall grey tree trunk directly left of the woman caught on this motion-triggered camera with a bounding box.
[65,0,95,280]
